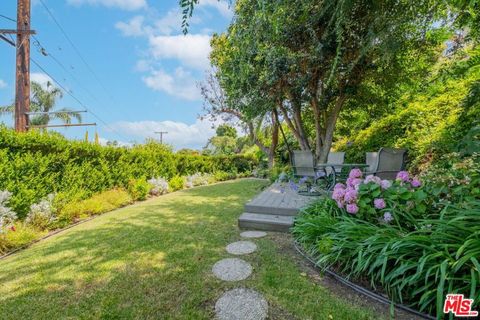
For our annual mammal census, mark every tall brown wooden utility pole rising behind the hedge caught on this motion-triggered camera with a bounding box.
[15,0,31,132]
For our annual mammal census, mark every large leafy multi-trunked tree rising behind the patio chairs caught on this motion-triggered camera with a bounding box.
[211,0,441,161]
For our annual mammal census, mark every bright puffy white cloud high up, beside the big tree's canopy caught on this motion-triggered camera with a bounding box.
[149,34,211,70]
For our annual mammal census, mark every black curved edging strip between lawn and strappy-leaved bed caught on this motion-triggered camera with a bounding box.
[293,240,436,320]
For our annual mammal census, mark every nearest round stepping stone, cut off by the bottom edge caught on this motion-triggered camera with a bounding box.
[215,288,268,320]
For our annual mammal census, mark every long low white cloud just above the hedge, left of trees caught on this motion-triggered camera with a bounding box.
[111,120,215,149]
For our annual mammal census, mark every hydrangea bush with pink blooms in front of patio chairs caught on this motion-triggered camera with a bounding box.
[332,169,427,227]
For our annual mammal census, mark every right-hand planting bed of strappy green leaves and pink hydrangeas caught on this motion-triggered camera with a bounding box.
[293,166,480,319]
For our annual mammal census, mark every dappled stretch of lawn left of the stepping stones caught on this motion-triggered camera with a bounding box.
[0,180,268,319]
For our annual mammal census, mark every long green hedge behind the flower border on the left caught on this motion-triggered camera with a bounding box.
[0,126,257,217]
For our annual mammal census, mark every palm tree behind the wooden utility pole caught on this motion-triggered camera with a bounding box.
[0,81,82,126]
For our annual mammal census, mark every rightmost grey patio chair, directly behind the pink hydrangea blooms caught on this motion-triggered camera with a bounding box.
[366,148,407,180]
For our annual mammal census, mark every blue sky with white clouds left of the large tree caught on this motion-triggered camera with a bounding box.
[0,0,232,148]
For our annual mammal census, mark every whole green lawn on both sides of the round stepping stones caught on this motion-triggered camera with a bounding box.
[0,180,378,319]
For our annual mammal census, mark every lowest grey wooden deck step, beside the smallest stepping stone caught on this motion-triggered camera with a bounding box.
[238,212,294,232]
